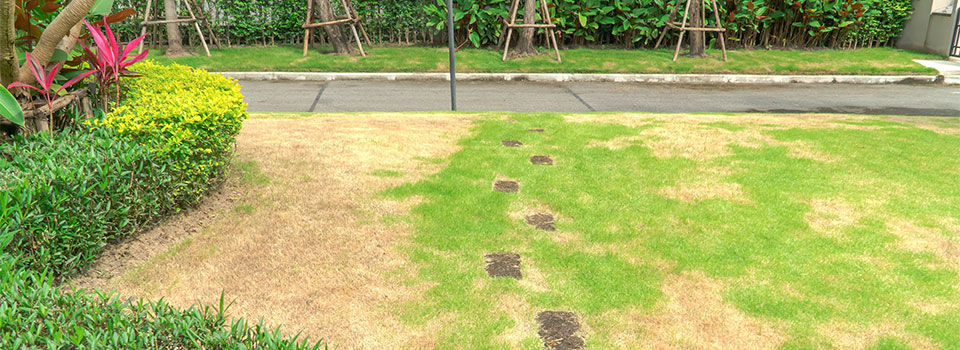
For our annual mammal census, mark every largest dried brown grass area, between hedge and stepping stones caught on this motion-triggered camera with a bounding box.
[68,114,474,349]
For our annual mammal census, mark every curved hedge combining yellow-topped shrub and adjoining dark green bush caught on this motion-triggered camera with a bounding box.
[0,63,247,275]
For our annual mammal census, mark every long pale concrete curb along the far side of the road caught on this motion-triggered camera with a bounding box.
[220,72,944,85]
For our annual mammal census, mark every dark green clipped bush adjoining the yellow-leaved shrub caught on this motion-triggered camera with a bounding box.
[0,129,176,275]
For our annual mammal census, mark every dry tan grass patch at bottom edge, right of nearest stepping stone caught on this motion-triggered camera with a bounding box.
[639,273,787,349]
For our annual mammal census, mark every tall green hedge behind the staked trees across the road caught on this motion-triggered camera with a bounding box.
[107,0,913,48]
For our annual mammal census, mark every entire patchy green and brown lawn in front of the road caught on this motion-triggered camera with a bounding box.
[77,113,960,349]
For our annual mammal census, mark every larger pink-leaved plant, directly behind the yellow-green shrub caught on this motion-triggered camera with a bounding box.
[80,19,149,106]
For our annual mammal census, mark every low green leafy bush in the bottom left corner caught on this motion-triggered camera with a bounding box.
[0,255,321,349]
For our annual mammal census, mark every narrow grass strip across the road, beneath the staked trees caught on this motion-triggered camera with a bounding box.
[151,47,939,75]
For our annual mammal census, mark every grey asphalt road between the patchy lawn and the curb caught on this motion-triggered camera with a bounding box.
[240,81,960,116]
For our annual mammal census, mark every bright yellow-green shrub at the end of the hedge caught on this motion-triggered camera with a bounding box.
[98,61,249,201]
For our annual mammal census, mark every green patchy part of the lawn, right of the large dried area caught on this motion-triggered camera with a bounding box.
[385,115,960,349]
